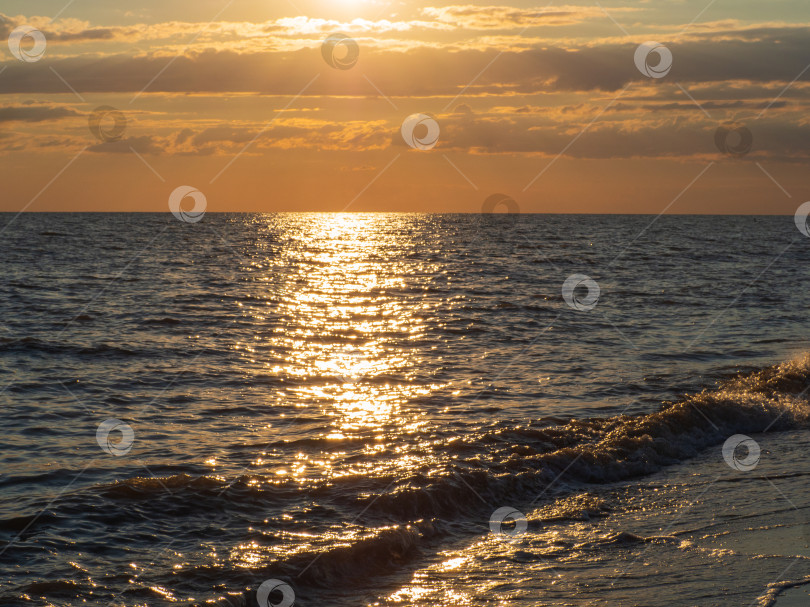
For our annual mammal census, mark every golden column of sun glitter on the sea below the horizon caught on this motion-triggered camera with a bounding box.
[229,213,438,479]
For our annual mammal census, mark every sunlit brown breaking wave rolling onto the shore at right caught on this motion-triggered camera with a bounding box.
[362,356,810,518]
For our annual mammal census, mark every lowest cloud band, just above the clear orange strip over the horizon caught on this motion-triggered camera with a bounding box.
[0,98,810,162]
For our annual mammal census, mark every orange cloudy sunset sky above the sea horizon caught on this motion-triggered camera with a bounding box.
[0,0,810,215]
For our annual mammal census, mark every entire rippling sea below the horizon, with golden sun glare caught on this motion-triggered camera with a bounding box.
[0,212,810,607]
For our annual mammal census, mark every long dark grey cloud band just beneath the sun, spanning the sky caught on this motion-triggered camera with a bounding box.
[0,27,810,97]
